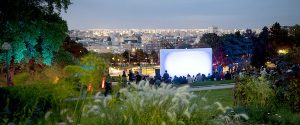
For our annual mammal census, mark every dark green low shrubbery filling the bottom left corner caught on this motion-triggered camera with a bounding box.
[0,83,76,124]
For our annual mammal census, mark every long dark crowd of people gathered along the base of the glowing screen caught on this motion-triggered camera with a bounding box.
[105,65,300,96]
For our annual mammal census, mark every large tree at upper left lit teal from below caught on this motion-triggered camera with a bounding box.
[0,0,71,84]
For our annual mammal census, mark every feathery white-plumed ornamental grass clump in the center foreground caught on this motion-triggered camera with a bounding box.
[79,82,247,125]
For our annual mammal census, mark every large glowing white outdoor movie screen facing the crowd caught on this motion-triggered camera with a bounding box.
[160,48,212,77]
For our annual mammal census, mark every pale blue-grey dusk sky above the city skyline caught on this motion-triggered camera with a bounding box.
[62,0,300,29]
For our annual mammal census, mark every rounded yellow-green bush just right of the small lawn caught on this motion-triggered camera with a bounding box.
[234,77,275,106]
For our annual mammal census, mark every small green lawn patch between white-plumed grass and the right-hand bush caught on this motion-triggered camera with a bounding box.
[194,88,233,107]
